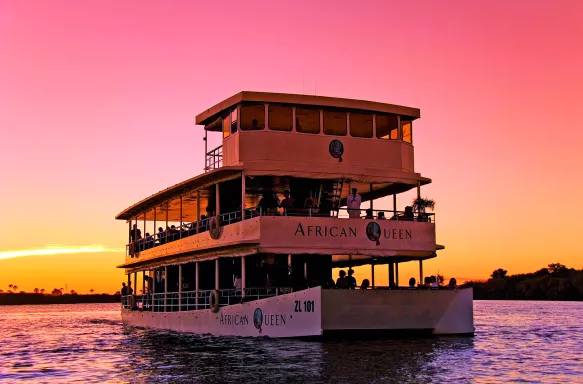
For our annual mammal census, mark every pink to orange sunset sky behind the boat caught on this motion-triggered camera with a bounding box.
[0,0,583,293]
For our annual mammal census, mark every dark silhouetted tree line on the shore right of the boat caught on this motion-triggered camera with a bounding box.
[461,263,583,301]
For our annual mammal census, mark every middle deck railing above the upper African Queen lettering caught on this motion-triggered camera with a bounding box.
[126,207,435,256]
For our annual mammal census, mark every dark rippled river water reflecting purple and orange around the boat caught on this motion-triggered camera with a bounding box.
[0,301,583,384]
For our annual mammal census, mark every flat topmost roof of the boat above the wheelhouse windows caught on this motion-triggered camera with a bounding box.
[196,91,421,125]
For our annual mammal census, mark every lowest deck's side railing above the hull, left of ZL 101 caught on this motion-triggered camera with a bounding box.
[121,287,293,312]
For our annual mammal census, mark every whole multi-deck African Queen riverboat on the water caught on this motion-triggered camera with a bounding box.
[116,92,474,338]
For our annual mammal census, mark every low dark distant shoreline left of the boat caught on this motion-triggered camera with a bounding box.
[0,293,121,306]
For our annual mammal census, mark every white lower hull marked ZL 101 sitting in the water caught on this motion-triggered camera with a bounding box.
[122,287,474,338]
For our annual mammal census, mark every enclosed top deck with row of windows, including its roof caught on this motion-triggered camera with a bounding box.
[196,92,428,185]
